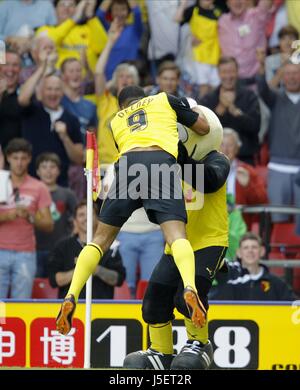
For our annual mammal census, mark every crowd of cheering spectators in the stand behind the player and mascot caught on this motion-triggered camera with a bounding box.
[0,0,300,298]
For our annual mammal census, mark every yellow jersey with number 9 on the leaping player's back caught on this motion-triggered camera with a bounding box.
[111,92,179,158]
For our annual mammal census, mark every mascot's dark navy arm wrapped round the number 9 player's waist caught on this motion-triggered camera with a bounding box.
[177,141,230,194]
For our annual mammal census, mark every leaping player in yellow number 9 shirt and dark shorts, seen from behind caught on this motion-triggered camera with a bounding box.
[56,86,209,334]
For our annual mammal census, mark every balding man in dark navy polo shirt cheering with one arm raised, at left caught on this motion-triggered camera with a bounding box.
[18,51,83,186]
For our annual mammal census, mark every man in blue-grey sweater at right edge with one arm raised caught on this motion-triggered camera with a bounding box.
[257,56,300,233]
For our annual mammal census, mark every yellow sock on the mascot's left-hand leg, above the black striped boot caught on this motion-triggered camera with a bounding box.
[149,321,173,354]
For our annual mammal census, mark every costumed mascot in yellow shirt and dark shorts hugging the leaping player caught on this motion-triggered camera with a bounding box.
[124,103,230,370]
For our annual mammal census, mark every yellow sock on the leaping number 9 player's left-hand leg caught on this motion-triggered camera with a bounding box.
[67,243,103,302]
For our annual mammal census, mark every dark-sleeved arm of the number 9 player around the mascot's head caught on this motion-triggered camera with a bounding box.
[167,94,209,135]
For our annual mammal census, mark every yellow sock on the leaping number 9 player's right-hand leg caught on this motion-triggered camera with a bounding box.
[171,238,197,291]
